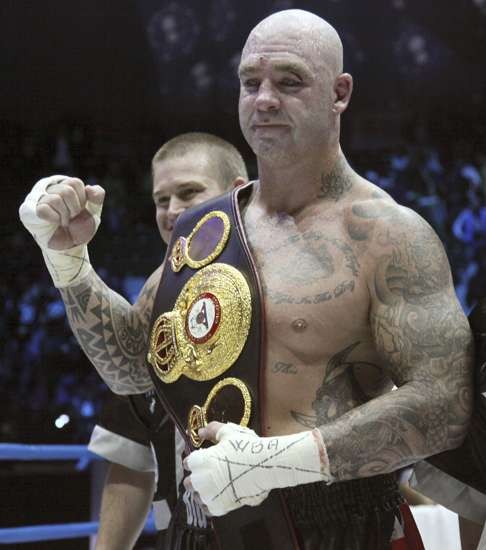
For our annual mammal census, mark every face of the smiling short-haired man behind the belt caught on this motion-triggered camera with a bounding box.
[153,150,224,243]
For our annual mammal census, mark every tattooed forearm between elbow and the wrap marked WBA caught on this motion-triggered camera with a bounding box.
[319,382,469,480]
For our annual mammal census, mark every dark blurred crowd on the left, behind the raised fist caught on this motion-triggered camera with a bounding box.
[0,122,165,443]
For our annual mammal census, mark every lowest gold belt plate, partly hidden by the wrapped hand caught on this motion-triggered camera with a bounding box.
[187,377,251,448]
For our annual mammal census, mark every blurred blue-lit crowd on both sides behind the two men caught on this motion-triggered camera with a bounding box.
[0,118,486,443]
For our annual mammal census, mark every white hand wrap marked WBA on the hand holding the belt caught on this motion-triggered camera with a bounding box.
[187,423,331,516]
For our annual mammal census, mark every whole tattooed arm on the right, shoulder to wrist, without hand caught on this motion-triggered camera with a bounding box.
[319,214,472,480]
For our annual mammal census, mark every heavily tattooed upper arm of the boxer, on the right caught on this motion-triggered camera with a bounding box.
[370,218,471,386]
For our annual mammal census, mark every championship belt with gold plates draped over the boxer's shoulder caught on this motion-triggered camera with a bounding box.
[147,184,298,550]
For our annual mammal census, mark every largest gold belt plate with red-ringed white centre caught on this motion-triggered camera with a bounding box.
[147,263,251,383]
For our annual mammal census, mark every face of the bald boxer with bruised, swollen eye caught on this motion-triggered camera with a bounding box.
[239,30,335,162]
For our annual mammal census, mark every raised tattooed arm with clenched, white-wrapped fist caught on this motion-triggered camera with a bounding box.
[19,176,162,394]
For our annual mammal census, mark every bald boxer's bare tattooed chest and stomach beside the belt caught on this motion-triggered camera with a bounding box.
[243,213,388,433]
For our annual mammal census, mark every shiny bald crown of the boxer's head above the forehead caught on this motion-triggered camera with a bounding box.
[242,9,343,77]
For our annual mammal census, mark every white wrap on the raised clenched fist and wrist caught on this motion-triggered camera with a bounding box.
[19,176,102,288]
